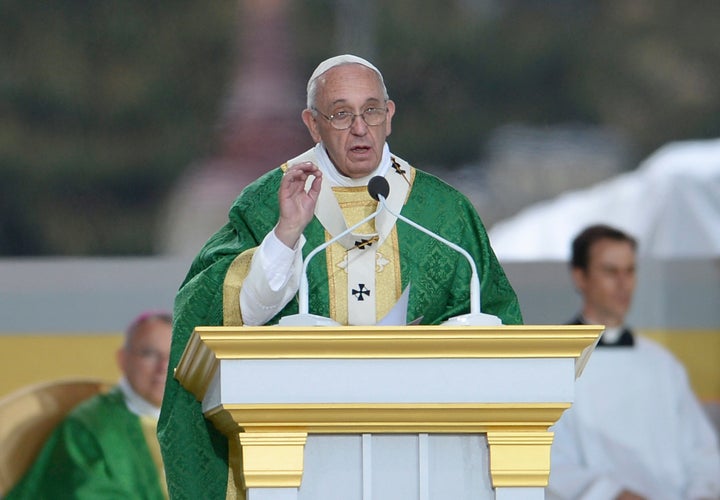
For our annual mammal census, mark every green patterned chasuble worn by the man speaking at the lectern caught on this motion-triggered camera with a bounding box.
[158,152,522,499]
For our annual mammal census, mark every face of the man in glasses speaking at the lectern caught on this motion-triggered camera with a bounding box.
[303,64,395,178]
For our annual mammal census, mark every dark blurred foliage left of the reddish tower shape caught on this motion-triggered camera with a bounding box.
[0,0,236,255]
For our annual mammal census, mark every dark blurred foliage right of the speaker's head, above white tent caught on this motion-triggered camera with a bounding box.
[377,0,720,167]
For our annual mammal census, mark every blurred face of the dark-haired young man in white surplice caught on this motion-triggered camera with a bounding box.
[573,239,635,327]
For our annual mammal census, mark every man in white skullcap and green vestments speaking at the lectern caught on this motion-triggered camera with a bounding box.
[158,55,522,499]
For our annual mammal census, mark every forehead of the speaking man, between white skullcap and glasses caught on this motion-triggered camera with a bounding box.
[318,64,383,103]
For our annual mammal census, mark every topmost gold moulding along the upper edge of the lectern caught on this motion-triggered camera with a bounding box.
[175,325,603,401]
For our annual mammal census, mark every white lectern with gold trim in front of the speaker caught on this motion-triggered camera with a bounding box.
[175,325,602,500]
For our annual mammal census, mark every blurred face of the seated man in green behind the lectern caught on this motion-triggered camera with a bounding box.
[118,319,172,407]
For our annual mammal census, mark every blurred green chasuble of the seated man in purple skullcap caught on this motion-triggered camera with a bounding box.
[5,387,165,500]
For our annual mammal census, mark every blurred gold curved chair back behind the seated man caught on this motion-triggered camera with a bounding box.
[0,378,113,498]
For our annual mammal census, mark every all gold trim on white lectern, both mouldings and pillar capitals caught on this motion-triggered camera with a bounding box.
[175,325,604,488]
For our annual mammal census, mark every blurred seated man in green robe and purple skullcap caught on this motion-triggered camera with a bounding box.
[6,312,172,500]
